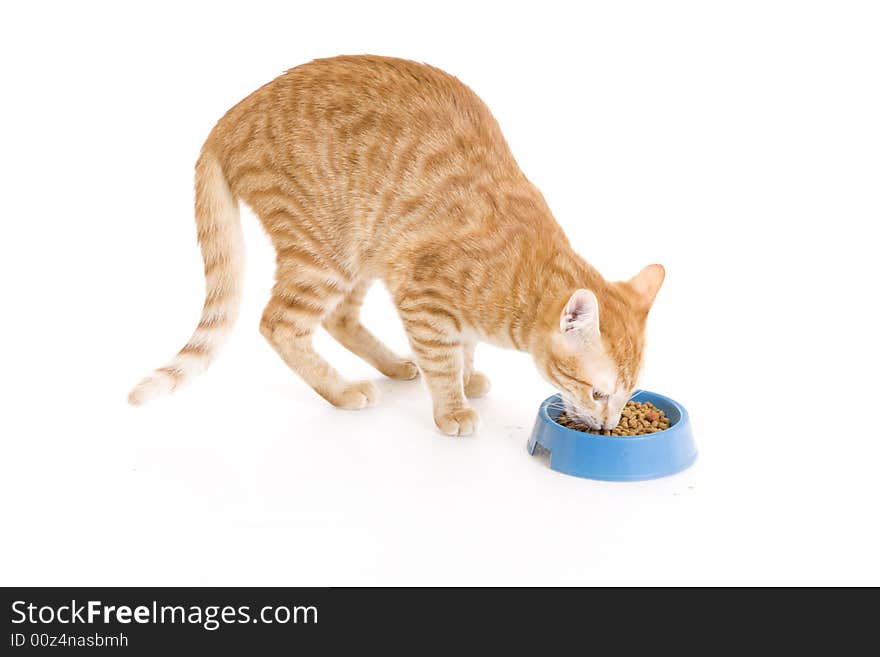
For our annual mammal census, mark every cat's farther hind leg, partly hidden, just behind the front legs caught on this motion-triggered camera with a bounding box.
[324,280,419,379]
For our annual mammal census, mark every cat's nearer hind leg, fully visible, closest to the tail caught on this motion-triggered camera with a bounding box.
[260,254,379,409]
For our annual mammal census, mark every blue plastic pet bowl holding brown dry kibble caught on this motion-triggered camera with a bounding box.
[529,390,697,481]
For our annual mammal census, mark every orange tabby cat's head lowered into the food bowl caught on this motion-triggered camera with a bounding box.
[533,265,665,429]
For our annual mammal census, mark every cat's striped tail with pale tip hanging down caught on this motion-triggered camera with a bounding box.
[128,149,244,406]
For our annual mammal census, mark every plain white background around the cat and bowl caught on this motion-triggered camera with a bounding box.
[0,0,880,585]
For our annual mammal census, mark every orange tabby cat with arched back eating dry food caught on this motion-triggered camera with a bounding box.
[129,56,664,435]
